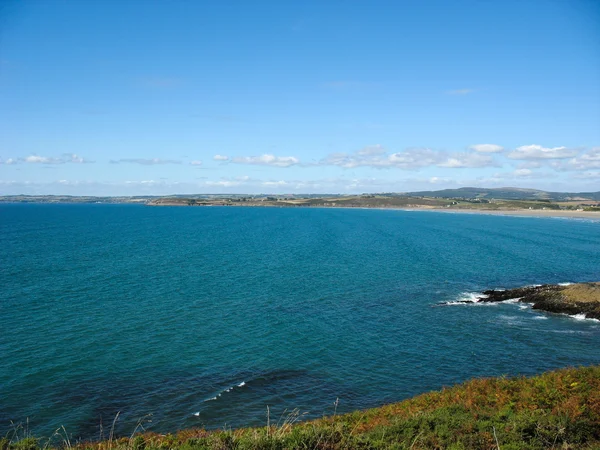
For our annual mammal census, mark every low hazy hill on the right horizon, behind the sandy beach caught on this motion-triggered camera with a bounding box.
[404,187,600,201]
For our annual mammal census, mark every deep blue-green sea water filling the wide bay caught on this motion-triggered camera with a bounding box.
[0,205,600,438]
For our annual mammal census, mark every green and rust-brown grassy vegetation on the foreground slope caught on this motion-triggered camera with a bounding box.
[0,366,600,450]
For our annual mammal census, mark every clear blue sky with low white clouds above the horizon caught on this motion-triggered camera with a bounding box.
[0,0,600,195]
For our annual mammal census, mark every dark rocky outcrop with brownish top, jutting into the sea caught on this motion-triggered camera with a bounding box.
[479,283,600,320]
